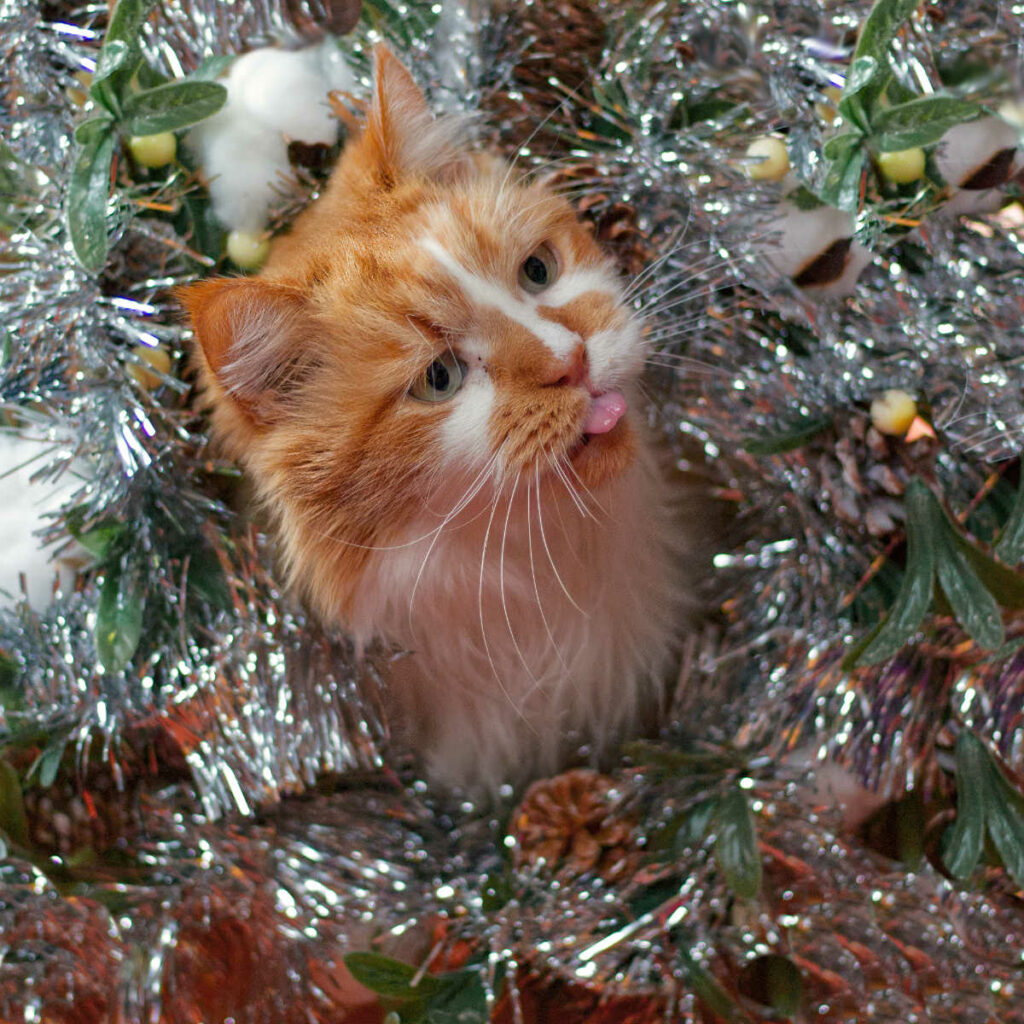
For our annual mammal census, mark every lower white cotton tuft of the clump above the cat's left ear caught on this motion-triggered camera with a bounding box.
[189,109,292,234]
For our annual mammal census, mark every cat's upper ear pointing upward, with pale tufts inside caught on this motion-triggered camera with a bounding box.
[361,43,470,185]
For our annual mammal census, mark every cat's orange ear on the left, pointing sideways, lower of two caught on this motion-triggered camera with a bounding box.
[178,278,312,424]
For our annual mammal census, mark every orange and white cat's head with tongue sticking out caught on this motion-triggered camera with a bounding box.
[183,48,644,617]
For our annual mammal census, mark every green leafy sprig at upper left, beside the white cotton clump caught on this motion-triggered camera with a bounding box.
[68,0,227,273]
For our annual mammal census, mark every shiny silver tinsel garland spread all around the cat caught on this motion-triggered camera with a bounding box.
[0,0,1024,1022]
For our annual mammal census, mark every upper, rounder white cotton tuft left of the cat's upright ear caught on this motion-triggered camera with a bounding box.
[228,49,338,145]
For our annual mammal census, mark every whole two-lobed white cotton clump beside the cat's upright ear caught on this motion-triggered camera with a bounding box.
[188,39,355,233]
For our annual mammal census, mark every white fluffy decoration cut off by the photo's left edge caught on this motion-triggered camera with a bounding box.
[0,429,81,609]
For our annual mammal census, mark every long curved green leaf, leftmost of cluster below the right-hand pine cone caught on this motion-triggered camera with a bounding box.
[843,478,939,669]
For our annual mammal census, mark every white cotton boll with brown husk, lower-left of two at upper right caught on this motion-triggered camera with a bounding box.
[762,201,873,297]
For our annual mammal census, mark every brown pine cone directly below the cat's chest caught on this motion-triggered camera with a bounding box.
[512,768,640,881]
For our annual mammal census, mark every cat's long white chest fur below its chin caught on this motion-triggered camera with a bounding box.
[346,432,690,792]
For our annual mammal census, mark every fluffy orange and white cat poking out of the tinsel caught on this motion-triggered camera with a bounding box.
[182,46,692,793]
